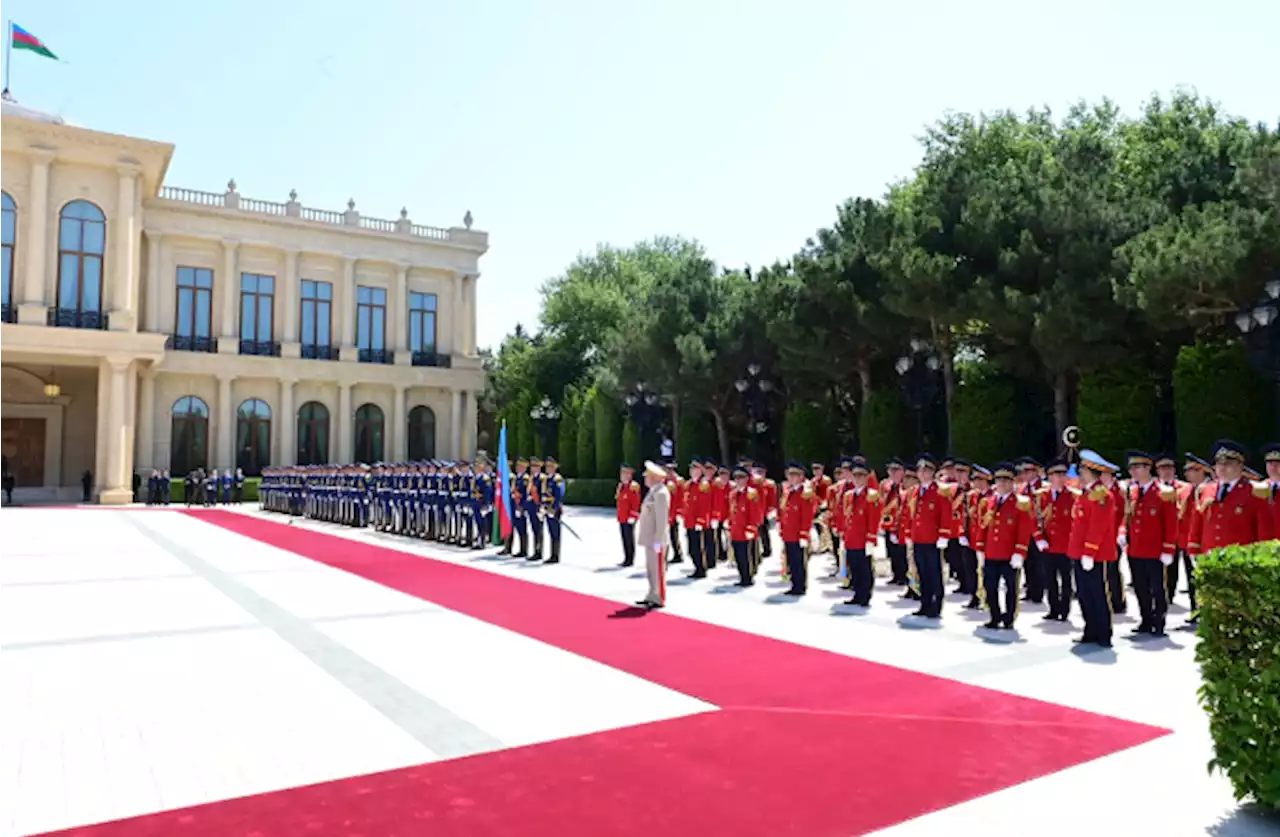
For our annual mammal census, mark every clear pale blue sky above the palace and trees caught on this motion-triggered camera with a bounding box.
[5,0,1280,346]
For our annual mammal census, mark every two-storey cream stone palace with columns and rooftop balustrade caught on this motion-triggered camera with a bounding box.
[0,99,489,504]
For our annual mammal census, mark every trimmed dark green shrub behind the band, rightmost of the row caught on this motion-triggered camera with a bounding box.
[1174,340,1274,457]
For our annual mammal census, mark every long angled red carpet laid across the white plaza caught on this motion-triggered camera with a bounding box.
[37,511,1167,837]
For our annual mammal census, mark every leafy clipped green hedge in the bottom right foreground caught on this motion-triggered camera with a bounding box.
[1196,540,1280,809]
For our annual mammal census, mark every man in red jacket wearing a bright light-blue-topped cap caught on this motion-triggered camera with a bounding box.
[1068,450,1123,648]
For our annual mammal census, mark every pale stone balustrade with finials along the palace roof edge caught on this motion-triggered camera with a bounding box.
[159,180,489,247]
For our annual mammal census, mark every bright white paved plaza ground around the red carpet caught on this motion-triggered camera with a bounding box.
[0,509,1280,837]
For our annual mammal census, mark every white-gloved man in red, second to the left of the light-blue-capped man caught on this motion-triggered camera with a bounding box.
[974,462,1036,630]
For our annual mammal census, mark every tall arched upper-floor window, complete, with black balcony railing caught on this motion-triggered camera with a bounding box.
[55,201,106,329]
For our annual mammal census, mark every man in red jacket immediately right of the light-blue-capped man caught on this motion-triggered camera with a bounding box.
[1117,450,1178,636]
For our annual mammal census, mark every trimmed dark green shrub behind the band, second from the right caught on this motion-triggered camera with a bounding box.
[1076,363,1161,462]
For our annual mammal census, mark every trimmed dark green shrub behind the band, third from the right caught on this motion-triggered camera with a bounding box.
[951,363,1024,465]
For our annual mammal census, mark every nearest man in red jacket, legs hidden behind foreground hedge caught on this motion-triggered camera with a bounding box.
[1187,439,1272,555]
